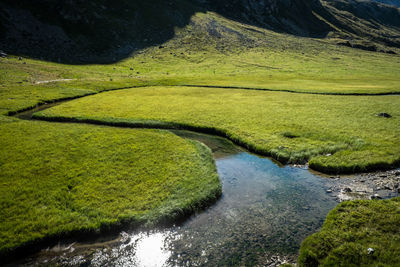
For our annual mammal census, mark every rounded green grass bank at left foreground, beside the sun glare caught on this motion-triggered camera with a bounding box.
[0,119,221,255]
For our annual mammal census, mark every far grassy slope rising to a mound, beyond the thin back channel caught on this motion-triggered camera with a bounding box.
[0,12,400,118]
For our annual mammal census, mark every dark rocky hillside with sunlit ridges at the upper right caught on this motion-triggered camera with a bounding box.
[194,0,400,47]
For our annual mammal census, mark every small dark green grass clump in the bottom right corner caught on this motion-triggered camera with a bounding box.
[298,197,400,267]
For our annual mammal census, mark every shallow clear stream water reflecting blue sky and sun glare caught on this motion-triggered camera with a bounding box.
[18,132,337,267]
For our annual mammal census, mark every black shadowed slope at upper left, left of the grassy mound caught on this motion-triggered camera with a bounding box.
[0,0,202,64]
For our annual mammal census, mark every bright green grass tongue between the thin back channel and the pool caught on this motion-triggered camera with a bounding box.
[34,87,400,173]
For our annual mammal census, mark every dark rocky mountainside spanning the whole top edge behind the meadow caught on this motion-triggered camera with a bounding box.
[0,0,400,64]
